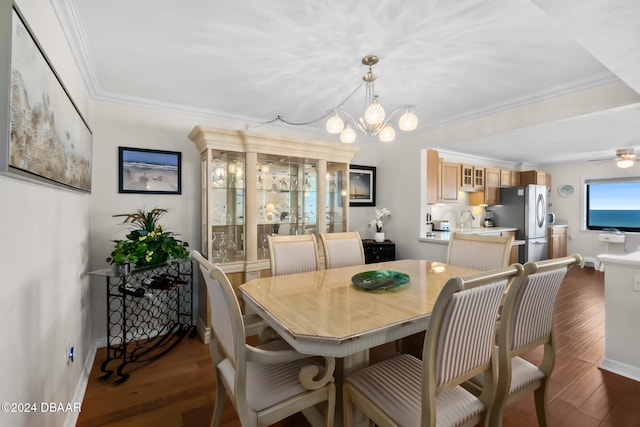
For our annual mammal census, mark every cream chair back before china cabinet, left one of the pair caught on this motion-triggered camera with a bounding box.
[267,234,320,276]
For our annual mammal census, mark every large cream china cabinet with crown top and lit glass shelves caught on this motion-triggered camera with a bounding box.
[189,126,358,280]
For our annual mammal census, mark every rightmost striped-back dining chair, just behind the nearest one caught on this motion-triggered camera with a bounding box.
[467,254,582,426]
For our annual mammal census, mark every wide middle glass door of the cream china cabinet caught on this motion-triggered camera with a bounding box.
[256,154,317,259]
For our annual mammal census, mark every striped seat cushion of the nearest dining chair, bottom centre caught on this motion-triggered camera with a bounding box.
[349,354,484,426]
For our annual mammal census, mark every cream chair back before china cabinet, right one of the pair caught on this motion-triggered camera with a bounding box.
[320,231,364,268]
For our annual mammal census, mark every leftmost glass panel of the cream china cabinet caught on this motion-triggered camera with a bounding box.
[208,150,245,262]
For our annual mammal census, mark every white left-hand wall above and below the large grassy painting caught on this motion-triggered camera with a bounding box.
[0,0,96,426]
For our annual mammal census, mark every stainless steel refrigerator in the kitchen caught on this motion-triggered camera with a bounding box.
[491,185,548,262]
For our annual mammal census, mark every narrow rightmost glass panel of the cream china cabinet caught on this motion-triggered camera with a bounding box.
[326,162,348,233]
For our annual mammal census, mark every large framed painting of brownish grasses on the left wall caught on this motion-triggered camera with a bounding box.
[0,1,93,193]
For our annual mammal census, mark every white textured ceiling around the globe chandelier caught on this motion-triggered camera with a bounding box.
[52,0,640,163]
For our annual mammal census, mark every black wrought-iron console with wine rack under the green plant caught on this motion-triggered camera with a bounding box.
[89,260,195,384]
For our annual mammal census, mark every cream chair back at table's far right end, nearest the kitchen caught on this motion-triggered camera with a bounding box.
[447,232,513,271]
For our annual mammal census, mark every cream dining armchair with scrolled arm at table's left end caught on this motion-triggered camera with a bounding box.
[192,253,336,427]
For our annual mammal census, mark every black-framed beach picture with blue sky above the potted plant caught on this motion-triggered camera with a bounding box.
[118,147,182,194]
